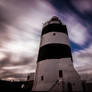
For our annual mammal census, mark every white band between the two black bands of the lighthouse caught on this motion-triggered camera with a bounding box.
[40,32,70,47]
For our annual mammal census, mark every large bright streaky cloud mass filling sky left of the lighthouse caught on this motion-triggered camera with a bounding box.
[0,0,56,79]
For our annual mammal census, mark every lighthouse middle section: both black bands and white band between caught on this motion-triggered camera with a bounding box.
[38,23,72,62]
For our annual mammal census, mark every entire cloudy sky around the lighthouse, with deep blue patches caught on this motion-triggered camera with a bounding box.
[0,0,92,80]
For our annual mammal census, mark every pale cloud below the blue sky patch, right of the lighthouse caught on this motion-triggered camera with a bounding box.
[72,44,92,80]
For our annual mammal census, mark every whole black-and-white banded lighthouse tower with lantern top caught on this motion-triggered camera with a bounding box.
[33,16,82,92]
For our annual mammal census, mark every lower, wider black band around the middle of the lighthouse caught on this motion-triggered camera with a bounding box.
[38,44,72,62]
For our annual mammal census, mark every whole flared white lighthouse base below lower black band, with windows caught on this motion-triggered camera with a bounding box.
[33,58,82,92]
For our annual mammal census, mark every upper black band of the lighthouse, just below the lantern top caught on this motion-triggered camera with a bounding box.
[42,24,68,35]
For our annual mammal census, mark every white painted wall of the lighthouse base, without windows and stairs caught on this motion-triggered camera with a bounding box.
[32,58,81,92]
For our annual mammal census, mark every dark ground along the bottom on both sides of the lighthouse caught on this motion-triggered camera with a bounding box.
[0,80,92,92]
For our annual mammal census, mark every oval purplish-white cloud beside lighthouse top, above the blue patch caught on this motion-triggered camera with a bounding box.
[59,11,89,46]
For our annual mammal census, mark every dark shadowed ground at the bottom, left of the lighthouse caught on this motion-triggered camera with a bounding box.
[0,80,33,92]
